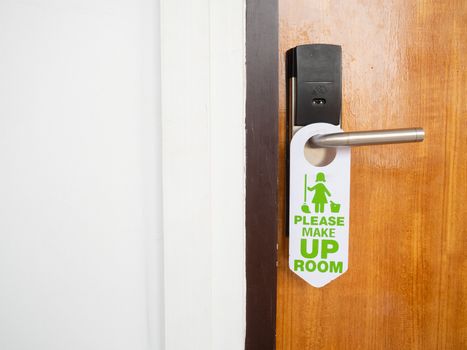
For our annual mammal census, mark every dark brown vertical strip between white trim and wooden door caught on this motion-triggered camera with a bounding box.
[245,0,279,350]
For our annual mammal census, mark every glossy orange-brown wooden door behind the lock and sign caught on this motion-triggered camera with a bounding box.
[277,0,467,350]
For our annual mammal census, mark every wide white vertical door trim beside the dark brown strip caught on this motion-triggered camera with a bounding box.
[161,0,249,350]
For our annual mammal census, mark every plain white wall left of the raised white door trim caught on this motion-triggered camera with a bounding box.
[0,0,163,350]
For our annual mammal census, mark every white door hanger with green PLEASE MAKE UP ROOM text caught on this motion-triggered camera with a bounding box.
[289,123,350,288]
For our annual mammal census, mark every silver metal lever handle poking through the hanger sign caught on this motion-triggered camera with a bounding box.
[310,128,425,147]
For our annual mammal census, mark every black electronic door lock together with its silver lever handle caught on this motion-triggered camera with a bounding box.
[286,44,425,148]
